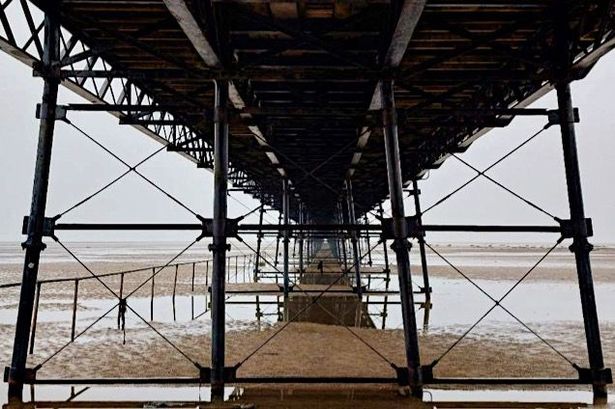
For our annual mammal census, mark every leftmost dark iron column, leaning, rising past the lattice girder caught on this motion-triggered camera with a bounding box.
[8,1,60,402]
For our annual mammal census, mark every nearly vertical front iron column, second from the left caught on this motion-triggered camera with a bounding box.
[210,81,228,399]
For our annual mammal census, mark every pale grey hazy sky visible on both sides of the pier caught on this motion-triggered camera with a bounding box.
[0,48,615,243]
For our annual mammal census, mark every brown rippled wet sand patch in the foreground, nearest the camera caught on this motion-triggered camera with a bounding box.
[0,320,615,378]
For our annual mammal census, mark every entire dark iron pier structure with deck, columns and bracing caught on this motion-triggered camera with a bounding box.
[0,0,615,402]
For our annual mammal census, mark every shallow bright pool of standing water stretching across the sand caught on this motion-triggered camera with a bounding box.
[0,278,615,340]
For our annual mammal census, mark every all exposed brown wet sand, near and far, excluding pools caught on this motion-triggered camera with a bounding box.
[0,241,615,404]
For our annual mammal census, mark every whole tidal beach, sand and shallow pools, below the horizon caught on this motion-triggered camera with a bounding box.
[0,243,615,404]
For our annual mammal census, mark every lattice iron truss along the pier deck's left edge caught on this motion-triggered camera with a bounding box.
[0,0,260,195]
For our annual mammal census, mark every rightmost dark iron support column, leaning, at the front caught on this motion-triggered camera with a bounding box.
[557,82,607,399]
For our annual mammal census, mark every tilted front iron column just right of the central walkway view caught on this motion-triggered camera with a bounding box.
[381,80,423,398]
